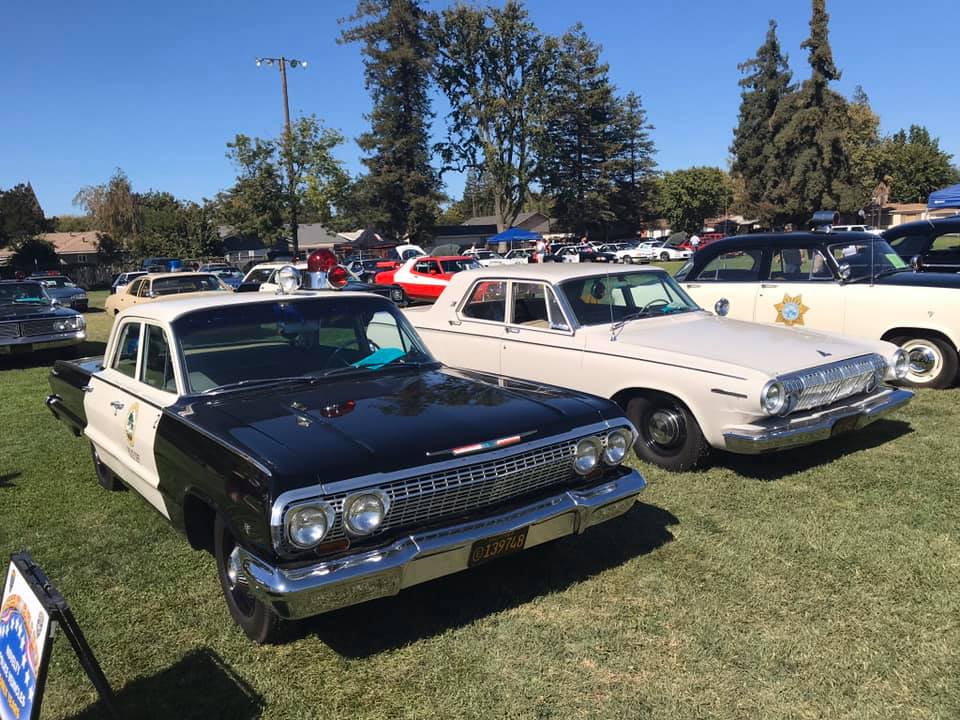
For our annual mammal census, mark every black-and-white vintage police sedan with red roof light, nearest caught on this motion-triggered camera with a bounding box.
[47,292,645,642]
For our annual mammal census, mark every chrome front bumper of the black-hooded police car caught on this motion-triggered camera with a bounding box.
[230,468,646,619]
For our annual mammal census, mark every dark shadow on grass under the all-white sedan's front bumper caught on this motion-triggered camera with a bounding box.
[714,420,913,480]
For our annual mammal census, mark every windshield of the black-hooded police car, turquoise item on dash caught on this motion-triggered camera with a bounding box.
[174,297,435,393]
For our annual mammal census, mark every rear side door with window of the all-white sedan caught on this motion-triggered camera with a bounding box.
[442,280,507,373]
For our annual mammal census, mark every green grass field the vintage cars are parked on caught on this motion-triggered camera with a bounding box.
[0,293,960,720]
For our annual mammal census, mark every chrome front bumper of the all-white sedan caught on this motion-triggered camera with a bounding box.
[723,388,913,455]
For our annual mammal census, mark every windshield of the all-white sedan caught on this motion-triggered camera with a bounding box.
[560,270,700,325]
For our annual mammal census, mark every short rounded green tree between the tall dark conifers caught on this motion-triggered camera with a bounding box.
[658,167,733,234]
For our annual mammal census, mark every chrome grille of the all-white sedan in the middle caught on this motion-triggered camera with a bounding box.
[780,354,887,412]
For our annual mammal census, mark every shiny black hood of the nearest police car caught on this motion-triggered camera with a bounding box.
[168,368,621,494]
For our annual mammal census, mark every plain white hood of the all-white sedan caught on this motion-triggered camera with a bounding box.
[588,312,893,377]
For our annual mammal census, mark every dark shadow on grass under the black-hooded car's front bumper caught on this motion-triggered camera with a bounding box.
[306,503,680,658]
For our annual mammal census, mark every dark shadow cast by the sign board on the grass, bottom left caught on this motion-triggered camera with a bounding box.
[65,648,264,720]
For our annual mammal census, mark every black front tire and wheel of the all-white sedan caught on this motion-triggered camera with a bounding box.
[627,393,710,472]
